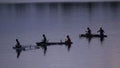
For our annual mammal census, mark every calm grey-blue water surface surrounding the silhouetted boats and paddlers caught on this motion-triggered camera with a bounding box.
[0,3,120,68]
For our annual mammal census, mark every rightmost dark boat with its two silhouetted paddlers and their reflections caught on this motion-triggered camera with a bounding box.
[79,27,107,43]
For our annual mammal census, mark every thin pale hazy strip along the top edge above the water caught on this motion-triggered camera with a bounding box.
[0,0,120,3]
